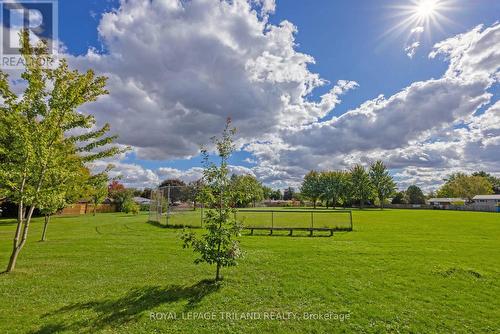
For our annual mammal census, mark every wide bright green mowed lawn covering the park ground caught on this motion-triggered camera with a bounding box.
[0,210,500,333]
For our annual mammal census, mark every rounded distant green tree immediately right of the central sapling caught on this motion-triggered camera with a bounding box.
[229,175,264,207]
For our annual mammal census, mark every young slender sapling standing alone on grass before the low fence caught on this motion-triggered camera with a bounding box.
[182,119,241,282]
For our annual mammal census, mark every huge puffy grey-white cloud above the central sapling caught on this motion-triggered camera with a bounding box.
[70,0,356,160]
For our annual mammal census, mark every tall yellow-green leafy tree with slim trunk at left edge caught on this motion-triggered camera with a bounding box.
[0,31,120,272]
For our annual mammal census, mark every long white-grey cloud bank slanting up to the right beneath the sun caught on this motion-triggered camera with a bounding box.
[247,24,500,189]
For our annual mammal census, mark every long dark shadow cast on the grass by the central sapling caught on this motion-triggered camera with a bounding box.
[33,280,220,333]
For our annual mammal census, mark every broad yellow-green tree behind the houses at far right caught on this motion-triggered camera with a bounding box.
[438,173,493,201]
